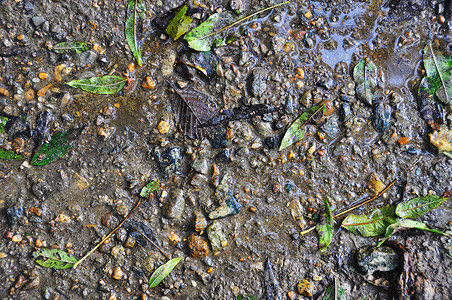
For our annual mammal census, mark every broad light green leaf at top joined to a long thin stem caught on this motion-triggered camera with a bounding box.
[184,11,234,51]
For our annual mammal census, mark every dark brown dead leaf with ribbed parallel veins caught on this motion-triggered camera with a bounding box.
[169,82,216,138]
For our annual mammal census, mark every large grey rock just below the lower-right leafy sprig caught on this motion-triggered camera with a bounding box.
[357,246,400,274]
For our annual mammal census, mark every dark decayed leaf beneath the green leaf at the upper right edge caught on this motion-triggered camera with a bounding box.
[417,77,446,130]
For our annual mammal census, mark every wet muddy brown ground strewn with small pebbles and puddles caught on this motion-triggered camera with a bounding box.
[0,0,452,299]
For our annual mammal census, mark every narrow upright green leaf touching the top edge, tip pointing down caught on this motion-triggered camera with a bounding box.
[125,0,146,67]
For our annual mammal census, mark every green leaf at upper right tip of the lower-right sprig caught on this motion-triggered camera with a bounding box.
[395,195,448,219]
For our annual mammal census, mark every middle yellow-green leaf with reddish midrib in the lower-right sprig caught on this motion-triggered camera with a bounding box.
[342,205,397,236]
